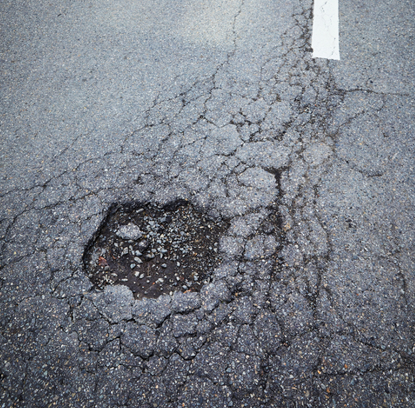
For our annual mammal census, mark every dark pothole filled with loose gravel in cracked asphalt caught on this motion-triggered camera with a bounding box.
[83,201,228,298]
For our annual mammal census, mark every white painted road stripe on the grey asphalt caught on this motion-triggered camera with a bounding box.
[311,0,340,60]
